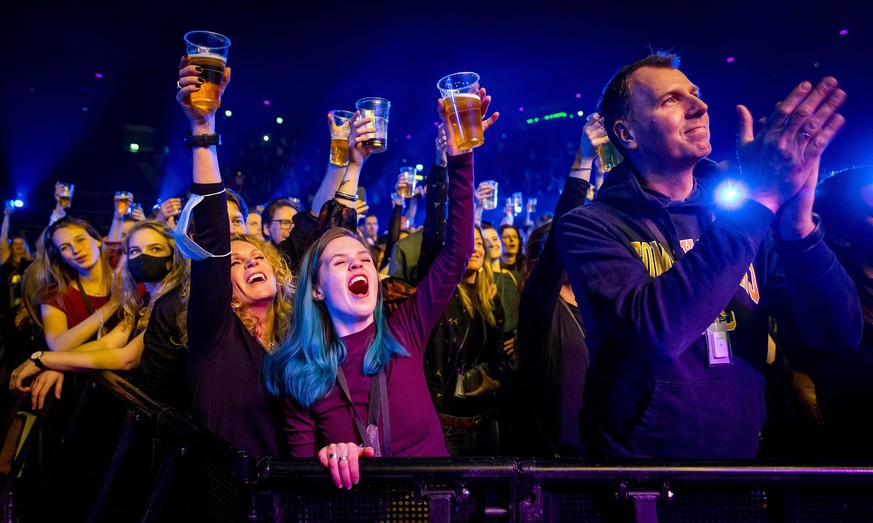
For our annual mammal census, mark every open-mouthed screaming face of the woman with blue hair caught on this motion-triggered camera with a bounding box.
[312,236,380,336]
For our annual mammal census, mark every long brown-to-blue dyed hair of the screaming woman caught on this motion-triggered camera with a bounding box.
[264,227,409,408]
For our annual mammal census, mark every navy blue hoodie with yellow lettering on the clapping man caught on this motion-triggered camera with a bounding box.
[557,160,862,459]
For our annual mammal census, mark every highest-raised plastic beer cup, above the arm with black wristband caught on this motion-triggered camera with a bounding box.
[185,31,230,111]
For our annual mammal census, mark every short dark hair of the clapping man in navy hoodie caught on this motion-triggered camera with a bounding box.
[597,51,681,155]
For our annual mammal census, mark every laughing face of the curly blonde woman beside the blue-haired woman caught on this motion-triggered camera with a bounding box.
[230,240,276,307]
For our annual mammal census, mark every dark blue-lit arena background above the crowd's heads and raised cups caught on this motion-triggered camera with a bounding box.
[0,0,873,240]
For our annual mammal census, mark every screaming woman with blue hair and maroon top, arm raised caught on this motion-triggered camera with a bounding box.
[264,89,499,488]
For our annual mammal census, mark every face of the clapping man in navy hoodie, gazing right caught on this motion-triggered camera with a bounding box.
[615,66,712,169]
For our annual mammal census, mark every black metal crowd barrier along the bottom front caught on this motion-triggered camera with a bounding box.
[0,372,873,523]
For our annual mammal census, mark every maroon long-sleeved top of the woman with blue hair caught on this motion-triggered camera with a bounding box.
[284,154,473,457]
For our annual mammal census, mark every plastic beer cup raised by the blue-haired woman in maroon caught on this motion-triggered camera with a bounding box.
[437,72,485,150]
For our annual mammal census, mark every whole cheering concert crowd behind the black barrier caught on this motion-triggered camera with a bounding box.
[0,48,873,500]
